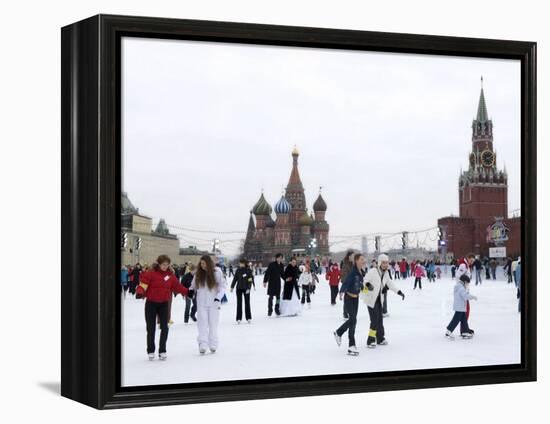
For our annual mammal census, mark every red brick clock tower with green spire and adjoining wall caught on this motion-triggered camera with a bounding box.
[437,79,521,258]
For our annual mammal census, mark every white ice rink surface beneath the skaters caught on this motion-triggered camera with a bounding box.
[122,268,521,386]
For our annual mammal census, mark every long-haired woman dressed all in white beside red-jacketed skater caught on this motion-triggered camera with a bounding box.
[190,255,226,355]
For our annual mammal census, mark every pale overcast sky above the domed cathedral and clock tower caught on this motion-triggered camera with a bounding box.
[122,38,521,254]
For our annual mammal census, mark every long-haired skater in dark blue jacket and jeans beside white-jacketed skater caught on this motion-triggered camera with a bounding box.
[333,253,367,356]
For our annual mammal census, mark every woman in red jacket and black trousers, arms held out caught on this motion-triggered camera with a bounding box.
[136,255,189,361]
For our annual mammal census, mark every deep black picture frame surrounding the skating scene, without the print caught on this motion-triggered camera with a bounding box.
[61,15,537,409]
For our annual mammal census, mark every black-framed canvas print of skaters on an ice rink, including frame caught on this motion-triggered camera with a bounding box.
[61,15,536,409]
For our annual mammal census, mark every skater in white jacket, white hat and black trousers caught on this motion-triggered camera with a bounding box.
[362,254,405,348]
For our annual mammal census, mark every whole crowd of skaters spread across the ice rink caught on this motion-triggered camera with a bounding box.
[120,250,521,360]
